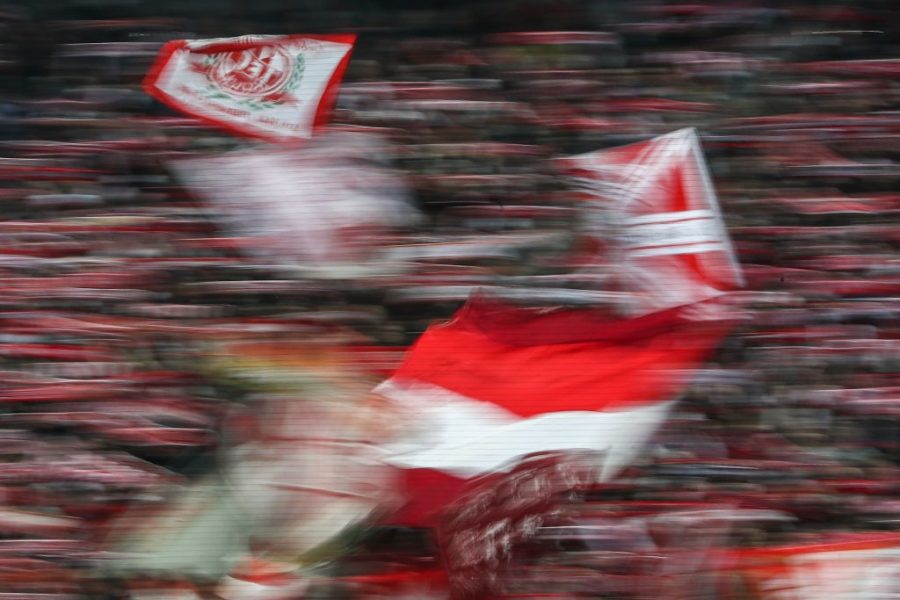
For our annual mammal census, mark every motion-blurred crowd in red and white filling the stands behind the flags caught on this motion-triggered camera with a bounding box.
[0,0,900,598]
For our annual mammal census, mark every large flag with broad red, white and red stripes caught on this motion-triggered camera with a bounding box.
[376,298,730,522]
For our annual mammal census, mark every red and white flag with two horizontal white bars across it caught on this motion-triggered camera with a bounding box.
[564,129,743,314]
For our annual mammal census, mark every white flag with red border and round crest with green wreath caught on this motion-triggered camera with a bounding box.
[144,34,356,142]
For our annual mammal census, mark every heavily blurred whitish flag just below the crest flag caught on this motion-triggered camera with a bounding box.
[172,131,419,278]
